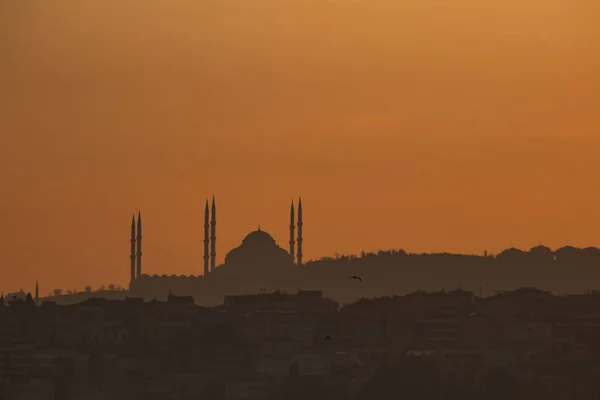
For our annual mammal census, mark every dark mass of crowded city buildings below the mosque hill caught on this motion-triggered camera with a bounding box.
[5,288,600,400]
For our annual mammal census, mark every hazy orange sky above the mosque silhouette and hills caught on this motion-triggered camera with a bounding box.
[0,0,600,294]
